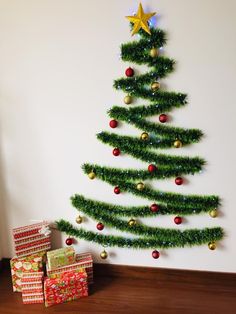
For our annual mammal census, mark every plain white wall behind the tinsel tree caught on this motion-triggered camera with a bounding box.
[0,0,236,272]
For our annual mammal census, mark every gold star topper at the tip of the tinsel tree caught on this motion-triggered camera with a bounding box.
[126,3,156,36]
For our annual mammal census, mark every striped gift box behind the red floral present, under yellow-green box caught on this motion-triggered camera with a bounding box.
[46,253,93,284]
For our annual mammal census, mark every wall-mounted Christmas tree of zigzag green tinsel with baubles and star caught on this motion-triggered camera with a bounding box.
[57,4,223,259]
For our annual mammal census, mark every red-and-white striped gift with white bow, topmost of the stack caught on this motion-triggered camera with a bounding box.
[13,222,51,257]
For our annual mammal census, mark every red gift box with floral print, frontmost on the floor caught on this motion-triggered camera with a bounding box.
[44,272,88,307]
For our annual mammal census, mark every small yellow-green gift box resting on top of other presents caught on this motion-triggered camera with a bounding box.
[47,247,75,270]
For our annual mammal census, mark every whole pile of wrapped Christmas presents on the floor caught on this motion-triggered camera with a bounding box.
[10,222,93,307]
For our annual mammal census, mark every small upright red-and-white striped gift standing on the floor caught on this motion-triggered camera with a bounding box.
[21,271,44,304]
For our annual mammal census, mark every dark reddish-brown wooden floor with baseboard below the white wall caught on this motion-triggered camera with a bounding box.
[0,265,236,314]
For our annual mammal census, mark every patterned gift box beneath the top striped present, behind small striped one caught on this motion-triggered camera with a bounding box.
[10,252,46,292]
